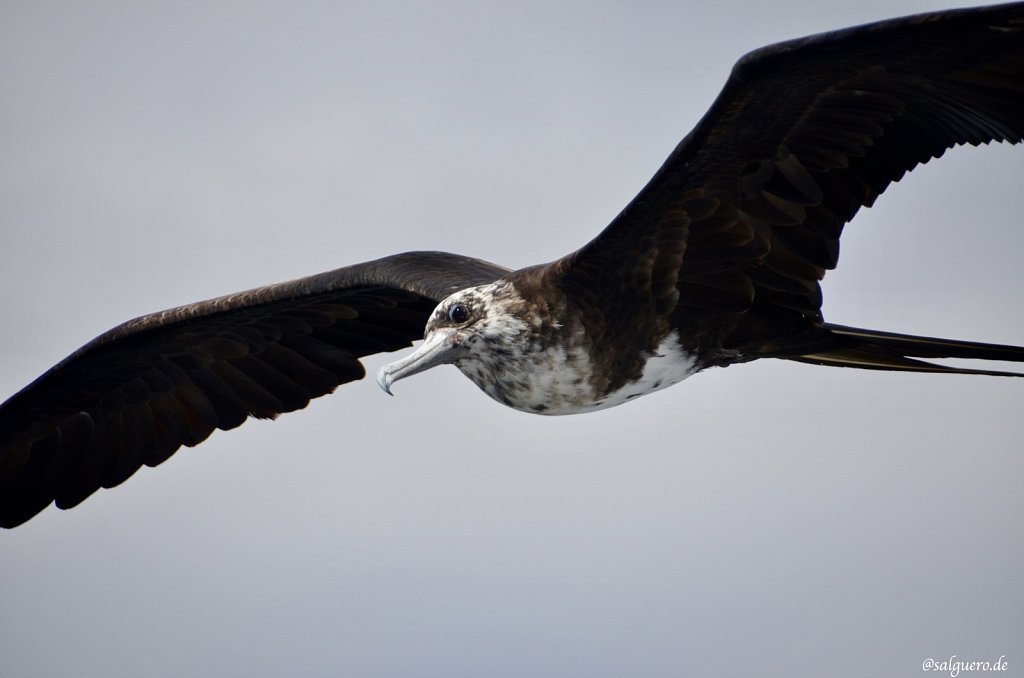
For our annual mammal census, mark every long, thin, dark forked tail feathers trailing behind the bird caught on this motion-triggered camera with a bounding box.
[790,324,1024,377]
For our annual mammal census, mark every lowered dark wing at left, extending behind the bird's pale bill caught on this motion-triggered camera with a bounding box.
[0,252,507,527]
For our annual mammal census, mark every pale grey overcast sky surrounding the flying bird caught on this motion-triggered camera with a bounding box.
[0,0,1024,678]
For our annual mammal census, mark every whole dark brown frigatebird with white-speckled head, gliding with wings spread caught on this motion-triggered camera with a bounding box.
[0,3,1024,527]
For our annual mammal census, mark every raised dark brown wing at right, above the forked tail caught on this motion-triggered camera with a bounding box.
[553,3,1024,331]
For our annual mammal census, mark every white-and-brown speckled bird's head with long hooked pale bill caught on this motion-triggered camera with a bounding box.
[377,281,530,395]
